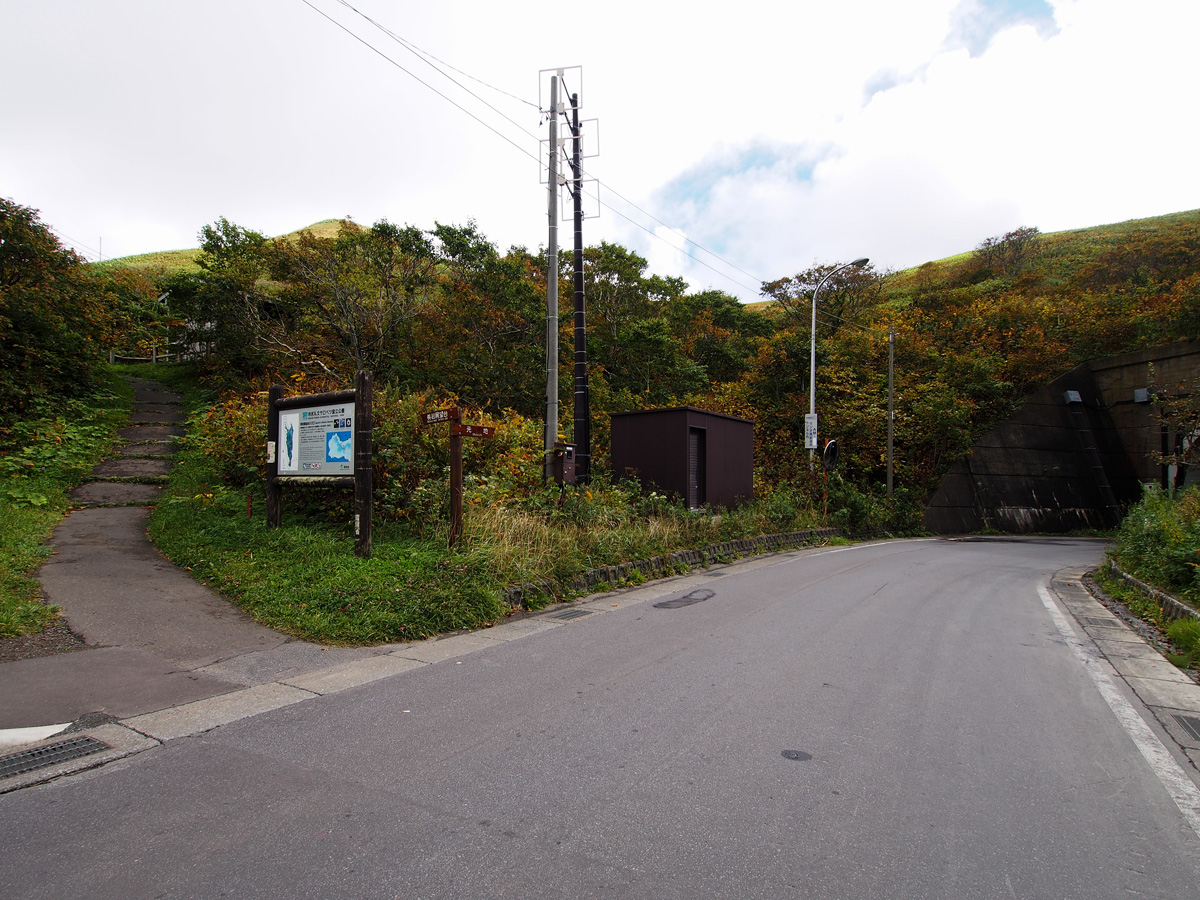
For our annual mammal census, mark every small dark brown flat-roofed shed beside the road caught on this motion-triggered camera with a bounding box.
[612,407,754,509]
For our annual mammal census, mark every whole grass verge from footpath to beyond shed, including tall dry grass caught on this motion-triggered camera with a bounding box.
[150,412,835,644]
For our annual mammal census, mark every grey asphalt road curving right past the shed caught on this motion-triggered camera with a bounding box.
[0,540,1200,900]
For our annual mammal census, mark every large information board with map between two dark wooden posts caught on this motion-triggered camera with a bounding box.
[266,370,372,559]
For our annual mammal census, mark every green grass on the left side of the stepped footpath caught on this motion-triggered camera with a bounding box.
[0,373,132,636]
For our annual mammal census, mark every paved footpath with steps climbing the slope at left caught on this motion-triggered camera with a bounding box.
[0,379,386,754]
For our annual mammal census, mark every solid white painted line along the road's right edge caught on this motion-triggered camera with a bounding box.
[1038,584,1200,836]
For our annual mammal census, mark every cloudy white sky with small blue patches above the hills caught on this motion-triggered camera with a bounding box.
[0,0,1200,301]
